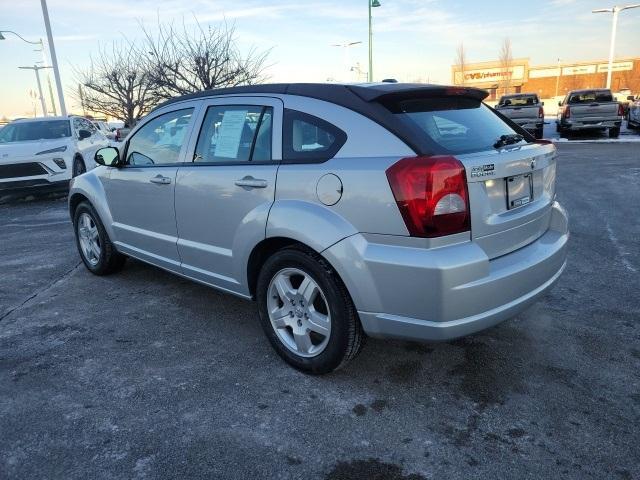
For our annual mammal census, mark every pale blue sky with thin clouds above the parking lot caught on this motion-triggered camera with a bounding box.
[0,0,640,118]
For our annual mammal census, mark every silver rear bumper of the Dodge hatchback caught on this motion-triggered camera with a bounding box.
[323,203,569,341]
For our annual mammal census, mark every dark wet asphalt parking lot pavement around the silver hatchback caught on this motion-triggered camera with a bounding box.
[0,144,640,480]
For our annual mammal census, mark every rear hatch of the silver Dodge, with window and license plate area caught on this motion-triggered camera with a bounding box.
[372,89,556,258]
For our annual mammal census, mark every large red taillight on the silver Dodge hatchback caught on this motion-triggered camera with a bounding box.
[386,156,470,238]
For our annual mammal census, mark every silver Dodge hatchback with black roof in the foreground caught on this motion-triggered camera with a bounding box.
[69,83,569,373]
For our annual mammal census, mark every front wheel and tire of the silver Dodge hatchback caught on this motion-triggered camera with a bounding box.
[73,202,126,275]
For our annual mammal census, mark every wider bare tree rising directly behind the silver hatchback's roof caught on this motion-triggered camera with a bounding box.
[138,21,269,98]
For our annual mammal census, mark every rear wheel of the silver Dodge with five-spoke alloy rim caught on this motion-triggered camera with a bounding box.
[256,247,364,374]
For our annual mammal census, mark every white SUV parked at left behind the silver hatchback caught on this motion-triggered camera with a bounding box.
[0,116,108,191]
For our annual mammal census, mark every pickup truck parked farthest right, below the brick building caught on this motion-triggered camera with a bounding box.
[556,89,624,138]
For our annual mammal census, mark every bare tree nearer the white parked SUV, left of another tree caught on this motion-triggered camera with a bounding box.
[72,41,161,126]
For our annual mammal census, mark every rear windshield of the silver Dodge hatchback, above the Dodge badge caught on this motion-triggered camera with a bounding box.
[387,97,526,154]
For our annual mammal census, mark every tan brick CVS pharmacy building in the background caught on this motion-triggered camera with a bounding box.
[451,58,640,100]
